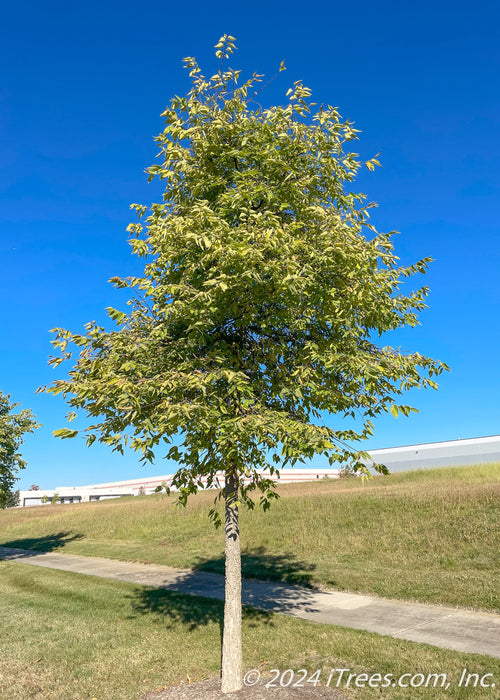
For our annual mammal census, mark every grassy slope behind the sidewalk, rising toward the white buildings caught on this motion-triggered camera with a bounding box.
[0,464,500,610]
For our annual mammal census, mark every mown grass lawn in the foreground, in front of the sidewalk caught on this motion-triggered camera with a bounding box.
[0,562,500,700]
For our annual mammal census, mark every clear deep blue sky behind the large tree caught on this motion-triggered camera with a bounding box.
[0,0,500,488]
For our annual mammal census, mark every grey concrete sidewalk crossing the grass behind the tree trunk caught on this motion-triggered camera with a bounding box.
[0,547,500,658]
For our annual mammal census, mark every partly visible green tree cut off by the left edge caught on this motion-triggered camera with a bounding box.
[0,391,40,508]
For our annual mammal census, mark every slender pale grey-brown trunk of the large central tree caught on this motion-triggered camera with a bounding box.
[222,470,243,693]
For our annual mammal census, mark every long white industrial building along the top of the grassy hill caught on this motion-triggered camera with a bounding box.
[19,435,500,507]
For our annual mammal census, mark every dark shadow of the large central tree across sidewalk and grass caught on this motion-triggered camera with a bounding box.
[131,547,317,636]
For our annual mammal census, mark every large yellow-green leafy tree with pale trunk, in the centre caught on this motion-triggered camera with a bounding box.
[47,35,445,692]
